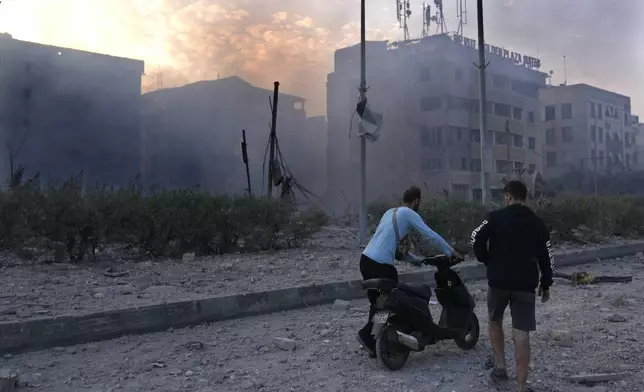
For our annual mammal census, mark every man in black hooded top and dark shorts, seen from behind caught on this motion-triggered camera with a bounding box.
[471,181,554,392]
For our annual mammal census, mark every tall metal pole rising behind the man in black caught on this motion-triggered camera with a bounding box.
[476,0,490,204]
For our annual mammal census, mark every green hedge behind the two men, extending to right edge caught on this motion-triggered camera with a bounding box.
[369,195,644,254]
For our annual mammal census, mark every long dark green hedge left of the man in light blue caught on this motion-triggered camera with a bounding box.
[0,177,326,261]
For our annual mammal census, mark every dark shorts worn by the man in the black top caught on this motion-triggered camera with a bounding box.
[487,287,537,332]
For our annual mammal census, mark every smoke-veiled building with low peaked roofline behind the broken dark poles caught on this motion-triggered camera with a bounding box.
[143,77,326,194]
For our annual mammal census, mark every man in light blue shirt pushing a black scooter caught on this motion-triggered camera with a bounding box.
[358,186,462,357]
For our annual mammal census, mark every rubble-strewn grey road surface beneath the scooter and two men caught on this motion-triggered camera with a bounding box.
[0,256,644,392]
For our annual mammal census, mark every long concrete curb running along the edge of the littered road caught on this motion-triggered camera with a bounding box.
[0,242,644,353]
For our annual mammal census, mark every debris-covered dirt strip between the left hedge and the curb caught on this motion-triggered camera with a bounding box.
[0,227,625,321]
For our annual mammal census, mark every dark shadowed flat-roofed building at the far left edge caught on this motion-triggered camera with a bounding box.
[0,34,143,185]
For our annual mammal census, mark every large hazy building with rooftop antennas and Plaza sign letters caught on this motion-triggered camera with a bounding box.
[327,35,547,206]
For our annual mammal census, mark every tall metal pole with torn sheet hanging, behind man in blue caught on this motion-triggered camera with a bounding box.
[358,0,367,245]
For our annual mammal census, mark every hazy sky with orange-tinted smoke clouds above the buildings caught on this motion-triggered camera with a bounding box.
[0,0,644,115]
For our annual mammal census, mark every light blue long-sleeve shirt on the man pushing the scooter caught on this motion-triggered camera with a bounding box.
[362,207,454,265]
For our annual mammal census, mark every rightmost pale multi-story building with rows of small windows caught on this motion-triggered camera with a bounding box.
[539,84,639,178]
